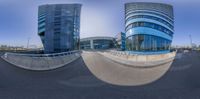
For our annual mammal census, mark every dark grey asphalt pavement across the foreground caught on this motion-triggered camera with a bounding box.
[0,52,200,99]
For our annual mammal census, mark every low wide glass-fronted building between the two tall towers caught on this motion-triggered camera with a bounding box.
[80,37,115,50]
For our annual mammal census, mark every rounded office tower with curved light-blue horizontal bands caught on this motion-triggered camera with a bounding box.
[125,2,174,52]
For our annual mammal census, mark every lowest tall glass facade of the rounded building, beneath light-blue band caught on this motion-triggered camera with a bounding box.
[126,34,171,51]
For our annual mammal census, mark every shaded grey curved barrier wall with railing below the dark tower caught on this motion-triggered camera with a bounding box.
[2,51,81,70]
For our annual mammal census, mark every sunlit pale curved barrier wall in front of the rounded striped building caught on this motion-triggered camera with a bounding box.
[103,50,176,67]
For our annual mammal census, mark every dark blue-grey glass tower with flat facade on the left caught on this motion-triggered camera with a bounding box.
[38,4,81,53]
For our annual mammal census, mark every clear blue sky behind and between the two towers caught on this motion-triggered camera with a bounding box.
[0,0,200,46]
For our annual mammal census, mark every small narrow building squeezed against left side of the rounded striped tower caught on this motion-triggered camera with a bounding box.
[115,32,126,50]
